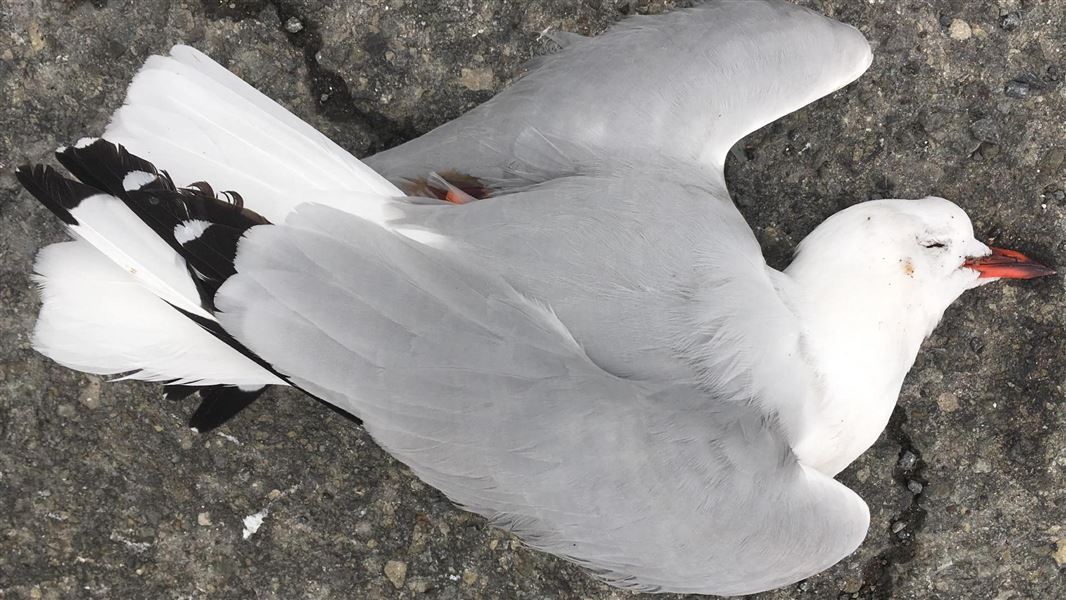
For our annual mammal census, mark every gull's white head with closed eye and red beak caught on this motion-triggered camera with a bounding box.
[787,197,1054,337]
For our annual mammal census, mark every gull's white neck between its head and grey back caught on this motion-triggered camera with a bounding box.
[778,260,935,474]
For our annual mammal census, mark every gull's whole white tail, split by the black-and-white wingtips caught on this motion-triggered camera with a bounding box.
[19,46,403,407]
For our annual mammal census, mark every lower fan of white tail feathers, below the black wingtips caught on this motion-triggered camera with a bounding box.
[33,240,286,386]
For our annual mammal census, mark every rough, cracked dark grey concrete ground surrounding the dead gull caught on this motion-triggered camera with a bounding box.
[0,0,1066,600]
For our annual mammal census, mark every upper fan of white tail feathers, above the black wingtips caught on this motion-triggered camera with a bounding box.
[103,46,403,223]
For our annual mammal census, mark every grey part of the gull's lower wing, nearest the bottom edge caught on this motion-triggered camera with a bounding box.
[215,206,869,595]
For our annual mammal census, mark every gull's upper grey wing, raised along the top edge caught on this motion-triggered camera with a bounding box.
[366,0,871,185]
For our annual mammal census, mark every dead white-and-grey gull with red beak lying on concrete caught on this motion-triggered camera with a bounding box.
[12,0,1052,595]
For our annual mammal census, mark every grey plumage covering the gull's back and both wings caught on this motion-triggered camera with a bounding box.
[207,2,870,594]
